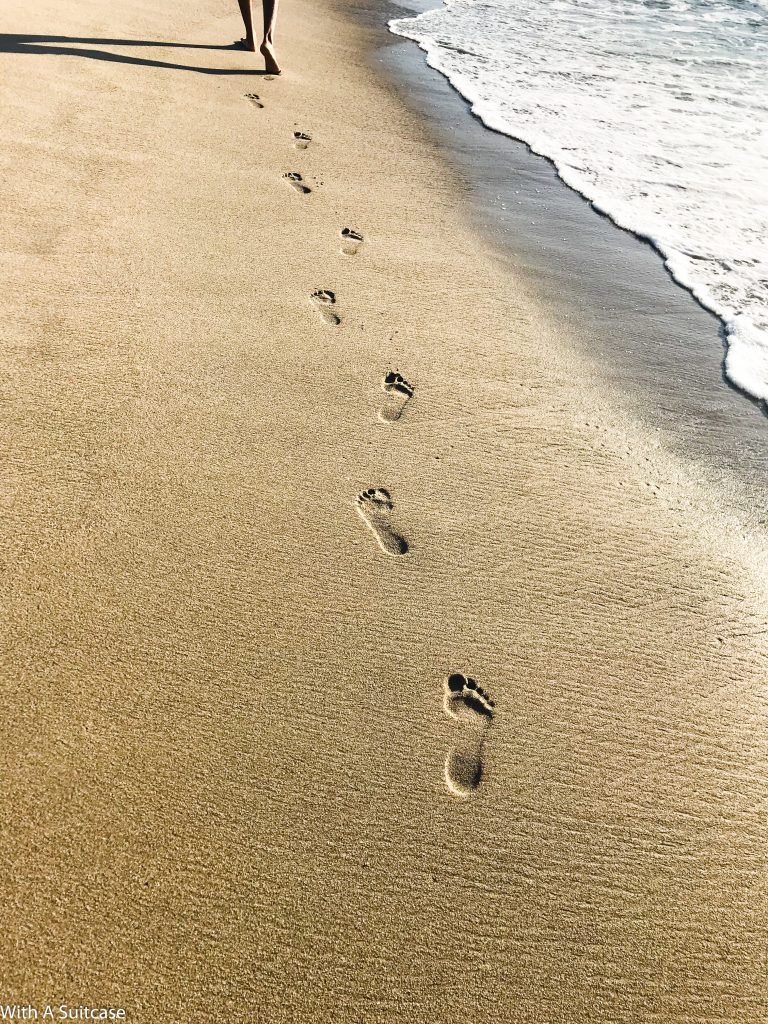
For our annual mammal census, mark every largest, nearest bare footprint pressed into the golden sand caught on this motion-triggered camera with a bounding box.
[443,672,496,800]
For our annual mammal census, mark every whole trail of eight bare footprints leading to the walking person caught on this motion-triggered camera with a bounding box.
[246,92,496,800]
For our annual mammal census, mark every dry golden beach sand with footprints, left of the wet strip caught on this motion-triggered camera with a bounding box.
[0,0,768,1024]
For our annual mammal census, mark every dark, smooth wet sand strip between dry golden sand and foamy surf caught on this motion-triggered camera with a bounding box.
[364,0,768,516]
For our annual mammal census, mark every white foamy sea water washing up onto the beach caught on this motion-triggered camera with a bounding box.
[390,0,768,401]
